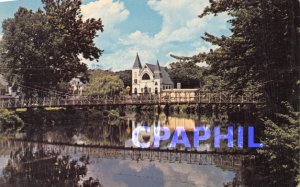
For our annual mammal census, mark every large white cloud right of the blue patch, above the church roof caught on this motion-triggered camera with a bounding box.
[116,0,228,66]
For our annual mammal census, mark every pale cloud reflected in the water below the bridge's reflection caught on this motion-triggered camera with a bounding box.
[120,160,233,187]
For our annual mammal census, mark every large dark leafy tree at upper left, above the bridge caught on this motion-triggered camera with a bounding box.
[0,0,103,96]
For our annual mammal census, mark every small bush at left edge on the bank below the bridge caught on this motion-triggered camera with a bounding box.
[0,110,24,133]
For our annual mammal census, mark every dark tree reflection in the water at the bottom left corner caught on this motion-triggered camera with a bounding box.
[0,147,102,187]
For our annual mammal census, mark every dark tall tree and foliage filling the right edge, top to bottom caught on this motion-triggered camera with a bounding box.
[171,0,300,186]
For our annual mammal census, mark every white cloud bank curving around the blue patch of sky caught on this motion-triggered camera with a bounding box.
[82,0,229,70]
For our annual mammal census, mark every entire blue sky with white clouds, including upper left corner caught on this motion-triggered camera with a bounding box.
[0,0,231,71]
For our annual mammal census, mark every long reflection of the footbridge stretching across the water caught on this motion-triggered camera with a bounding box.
[0,140,254,170]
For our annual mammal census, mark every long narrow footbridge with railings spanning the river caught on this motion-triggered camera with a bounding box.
[0,93,263,109]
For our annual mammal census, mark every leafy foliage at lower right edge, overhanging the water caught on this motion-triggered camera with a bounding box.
[258,102,300,185]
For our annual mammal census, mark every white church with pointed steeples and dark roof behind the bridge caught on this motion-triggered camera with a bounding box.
[132,54,174,94]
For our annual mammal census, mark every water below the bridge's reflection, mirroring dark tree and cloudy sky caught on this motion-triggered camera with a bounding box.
[0,142,236,187]
